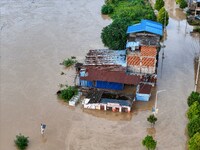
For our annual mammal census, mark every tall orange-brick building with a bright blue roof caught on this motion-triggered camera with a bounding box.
[126,20,163,85]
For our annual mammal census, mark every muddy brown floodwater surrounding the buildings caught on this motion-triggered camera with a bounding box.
[0,0,199,150]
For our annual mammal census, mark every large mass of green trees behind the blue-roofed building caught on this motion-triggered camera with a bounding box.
[101,0,156,50]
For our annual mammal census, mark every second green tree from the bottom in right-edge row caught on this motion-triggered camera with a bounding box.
[187,117,200,138]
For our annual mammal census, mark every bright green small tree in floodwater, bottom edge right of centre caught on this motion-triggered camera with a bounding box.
[142,135,157,150]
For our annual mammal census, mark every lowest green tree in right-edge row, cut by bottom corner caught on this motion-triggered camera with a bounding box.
[188,132,200,150]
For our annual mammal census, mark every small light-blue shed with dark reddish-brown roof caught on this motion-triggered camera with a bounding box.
[136,83,152,101]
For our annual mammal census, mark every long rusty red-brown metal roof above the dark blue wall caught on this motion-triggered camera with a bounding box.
[80,67,140,85]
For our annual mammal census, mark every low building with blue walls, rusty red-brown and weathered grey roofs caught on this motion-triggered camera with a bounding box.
[80,50,140,90]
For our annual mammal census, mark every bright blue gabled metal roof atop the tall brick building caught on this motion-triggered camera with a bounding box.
[126,19,163,36]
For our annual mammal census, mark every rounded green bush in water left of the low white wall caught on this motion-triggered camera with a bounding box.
[58,86,78,102]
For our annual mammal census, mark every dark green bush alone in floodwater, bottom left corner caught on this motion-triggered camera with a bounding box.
[14,133,29,150]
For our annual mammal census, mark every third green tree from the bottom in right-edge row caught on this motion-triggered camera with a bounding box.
[187,101,200,120]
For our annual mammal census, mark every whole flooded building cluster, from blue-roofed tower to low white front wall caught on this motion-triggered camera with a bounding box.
[76,20,163,112]
